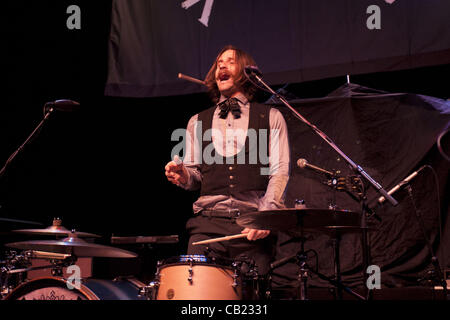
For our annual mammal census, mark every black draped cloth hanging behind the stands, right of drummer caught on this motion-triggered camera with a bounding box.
[273,84,450,287]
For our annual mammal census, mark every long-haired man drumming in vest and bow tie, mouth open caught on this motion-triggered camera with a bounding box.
[165,46,289,275]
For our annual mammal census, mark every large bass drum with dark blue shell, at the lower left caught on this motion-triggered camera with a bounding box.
[5,277,146,300]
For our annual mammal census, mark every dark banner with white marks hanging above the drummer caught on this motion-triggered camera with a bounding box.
[105,0,450,97]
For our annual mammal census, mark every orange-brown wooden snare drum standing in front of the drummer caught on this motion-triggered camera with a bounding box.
[153,255,242,300]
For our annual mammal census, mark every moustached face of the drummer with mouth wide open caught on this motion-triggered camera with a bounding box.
[216,50,240,97]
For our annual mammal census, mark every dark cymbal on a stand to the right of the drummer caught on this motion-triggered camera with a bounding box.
[236,208,361,231]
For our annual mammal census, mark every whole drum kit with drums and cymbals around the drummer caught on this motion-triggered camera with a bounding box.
[0,208,368,300]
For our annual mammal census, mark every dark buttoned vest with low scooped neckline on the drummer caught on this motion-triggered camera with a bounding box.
[197,103,270,196]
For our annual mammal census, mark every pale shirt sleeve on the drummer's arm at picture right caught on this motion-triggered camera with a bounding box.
[258,108,290,211]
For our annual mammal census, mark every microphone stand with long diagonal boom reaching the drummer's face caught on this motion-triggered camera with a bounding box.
[248,70,398,298]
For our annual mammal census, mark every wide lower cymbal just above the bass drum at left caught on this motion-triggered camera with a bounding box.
[5,235,137,258]
